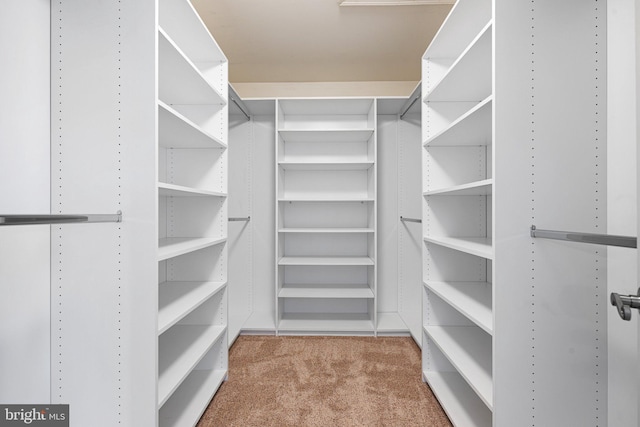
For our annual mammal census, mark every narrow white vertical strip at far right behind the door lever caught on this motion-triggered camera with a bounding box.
[607,0,640,426]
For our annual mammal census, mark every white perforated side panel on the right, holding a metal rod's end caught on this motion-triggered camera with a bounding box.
[494,0,609,427]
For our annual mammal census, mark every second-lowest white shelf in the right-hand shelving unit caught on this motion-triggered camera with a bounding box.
[424,326,493,409]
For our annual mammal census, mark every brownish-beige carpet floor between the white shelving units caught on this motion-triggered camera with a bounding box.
[198,336,451,427]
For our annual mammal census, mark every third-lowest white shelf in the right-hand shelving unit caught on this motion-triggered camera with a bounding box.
[424,281,493,335]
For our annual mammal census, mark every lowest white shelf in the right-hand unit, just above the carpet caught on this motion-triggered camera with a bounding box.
[423,372,492,427]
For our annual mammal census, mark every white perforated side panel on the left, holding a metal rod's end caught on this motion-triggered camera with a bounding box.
[51,0,158,426]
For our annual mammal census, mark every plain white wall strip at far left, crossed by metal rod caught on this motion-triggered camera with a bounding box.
[0,0,51,404]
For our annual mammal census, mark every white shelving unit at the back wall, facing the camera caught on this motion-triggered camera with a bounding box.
[275,99,377,334]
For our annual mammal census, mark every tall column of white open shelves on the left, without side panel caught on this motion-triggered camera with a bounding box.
[158,0,228,426]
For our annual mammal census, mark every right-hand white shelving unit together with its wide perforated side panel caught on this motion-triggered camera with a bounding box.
[422,0,607,427]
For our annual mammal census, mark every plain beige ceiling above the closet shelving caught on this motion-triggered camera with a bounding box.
[192,0,451,83]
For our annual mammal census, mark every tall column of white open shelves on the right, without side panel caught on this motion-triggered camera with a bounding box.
[422,0,494,426]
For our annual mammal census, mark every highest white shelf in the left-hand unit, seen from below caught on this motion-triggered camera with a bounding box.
[158,28,226,105]
